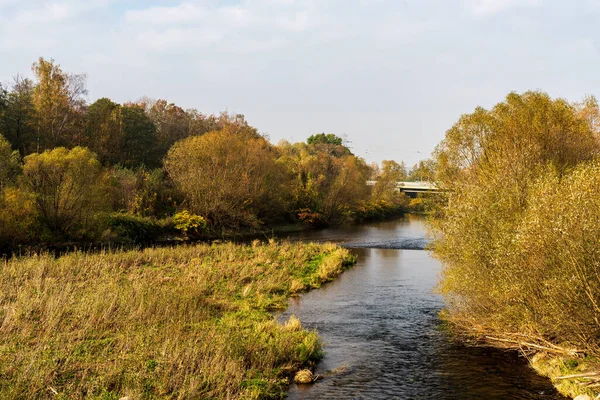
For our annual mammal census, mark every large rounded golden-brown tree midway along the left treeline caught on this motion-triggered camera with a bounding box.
[165,125,281,228]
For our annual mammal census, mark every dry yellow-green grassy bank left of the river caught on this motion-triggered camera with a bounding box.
[0,242,353,400]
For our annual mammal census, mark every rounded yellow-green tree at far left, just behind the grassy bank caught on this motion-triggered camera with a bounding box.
[23,147,106,238]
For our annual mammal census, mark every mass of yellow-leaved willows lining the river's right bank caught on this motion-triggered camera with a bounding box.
[434,92,600,372]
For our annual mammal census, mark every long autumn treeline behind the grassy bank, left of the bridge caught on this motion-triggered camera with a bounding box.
[0,58,428,248]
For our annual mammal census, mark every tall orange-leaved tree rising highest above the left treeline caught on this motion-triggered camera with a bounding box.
[32,57,87,149]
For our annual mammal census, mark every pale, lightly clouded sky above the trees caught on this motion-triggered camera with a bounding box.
[0,0,600,167]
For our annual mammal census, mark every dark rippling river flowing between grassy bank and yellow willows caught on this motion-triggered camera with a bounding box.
[279,217,564,400]
